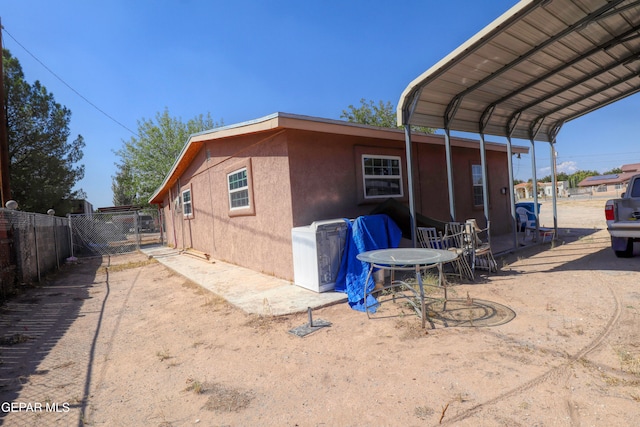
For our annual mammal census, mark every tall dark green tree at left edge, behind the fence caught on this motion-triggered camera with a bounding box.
[2,49,86,213]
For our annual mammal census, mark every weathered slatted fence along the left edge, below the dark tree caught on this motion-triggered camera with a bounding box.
[0,209,71,300]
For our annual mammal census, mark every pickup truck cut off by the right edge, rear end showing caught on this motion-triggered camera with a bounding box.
[604,175,640,258]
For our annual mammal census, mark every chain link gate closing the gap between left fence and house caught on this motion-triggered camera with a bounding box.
[69,211,162,257]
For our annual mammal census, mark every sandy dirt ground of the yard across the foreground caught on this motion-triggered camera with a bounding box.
[0,199,640,427]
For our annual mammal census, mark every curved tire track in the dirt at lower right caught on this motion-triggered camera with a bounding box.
[439,270,622,425]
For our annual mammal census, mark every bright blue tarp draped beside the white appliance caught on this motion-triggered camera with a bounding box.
[335,214,402,311]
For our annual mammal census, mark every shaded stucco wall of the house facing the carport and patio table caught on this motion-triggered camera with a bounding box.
[288,131,511,234]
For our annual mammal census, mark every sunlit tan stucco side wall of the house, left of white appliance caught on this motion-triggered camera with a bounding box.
[164,134,293,279]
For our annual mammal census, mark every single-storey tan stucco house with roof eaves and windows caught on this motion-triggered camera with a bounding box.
[150,113,528,280]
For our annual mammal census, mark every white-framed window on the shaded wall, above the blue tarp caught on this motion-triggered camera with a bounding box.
[362,154,403,199]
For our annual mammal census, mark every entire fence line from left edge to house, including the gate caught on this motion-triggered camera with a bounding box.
[0,208,163,301]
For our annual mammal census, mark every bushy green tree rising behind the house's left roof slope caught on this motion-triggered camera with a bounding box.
[111,108,222,206]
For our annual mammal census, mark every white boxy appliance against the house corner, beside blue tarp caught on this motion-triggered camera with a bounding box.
[291,218,347,292]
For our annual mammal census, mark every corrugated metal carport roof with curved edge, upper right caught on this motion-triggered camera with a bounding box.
[398,0,640,142]
